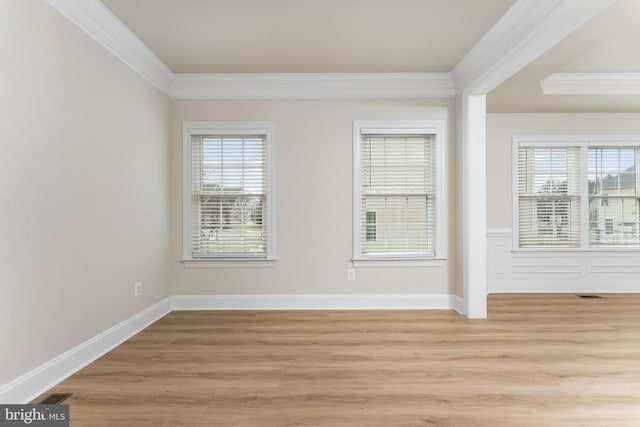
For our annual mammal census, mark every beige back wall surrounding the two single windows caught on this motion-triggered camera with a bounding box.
[170,100,456,294]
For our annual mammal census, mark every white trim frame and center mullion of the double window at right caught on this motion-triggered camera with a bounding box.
[511,135,640,252]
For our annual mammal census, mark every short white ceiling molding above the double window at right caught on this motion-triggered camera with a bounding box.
[540,73,640,95]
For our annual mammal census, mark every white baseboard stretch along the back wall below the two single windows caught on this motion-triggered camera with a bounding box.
[173,294,456,310]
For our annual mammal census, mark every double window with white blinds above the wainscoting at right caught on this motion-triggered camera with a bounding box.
[514,136,640,249]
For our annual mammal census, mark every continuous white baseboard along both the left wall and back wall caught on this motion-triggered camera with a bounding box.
[0,294,462,404]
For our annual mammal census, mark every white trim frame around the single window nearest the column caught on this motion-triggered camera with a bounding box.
[351,120,448,267]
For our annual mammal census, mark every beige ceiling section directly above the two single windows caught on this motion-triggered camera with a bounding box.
[103,0,513,73]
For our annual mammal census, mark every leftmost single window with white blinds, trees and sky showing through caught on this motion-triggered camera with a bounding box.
[184,122,273,261]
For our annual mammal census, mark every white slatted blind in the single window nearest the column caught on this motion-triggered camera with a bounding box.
[359,133,436,257]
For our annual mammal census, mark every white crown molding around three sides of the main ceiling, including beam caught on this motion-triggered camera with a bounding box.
[46,0,613,99]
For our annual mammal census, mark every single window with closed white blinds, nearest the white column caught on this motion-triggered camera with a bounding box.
[354,121,443,261]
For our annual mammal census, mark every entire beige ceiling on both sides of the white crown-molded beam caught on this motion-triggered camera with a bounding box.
[102,0,640,113]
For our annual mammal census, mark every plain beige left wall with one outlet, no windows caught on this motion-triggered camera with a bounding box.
[0,0,170,385]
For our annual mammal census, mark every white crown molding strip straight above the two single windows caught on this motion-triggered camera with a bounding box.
[169,73,455,99]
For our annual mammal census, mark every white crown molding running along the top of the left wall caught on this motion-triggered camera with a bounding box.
[46,0,173,93]
